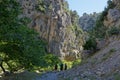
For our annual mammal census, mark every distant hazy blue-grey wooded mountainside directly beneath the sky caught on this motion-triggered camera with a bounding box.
[79,13,99,31]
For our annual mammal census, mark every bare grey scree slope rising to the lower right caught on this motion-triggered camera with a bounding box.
[59,36,120,80]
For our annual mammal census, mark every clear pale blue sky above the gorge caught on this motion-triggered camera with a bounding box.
[66,0,107,16]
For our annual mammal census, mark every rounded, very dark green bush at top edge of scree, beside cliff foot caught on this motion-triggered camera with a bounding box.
[83,37,97,50]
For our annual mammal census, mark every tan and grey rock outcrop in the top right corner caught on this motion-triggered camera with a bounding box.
[104,0,120,27]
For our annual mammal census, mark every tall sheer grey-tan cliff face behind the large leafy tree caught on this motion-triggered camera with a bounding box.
[18,0,83,58]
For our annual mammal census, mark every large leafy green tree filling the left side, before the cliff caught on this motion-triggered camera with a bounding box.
[0,0,55,72]
